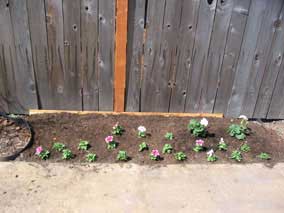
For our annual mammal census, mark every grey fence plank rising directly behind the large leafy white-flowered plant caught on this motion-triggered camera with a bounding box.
[185,0,217,112]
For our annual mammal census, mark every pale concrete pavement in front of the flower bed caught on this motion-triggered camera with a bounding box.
[0,162,284,213]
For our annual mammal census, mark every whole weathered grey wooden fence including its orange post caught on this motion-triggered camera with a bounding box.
[0,0,284,118]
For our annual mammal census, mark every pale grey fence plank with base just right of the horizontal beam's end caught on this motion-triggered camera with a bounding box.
[227,0,268,117]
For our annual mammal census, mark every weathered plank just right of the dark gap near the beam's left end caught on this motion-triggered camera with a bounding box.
[27,0,49,108]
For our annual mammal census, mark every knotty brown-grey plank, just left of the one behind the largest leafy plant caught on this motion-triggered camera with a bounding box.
[170,1,200,112]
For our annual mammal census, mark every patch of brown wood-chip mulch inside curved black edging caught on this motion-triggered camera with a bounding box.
[0,116,31,160]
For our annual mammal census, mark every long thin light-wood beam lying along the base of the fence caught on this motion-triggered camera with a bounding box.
[29,109,224,118]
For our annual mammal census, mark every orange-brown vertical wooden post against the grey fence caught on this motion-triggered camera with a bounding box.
[114,0,128,112]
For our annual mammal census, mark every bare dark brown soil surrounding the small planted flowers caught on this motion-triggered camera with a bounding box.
[17,114,284,165]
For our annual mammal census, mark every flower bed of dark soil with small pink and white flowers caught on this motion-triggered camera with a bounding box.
[19,113,284,164]
